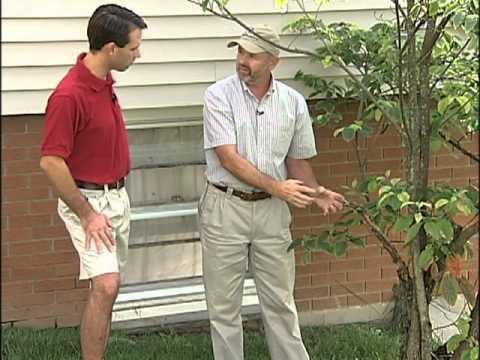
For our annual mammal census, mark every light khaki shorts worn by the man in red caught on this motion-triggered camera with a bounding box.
[58,187,130,280]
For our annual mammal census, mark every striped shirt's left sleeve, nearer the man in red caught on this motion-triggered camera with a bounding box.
[203,88,237,149]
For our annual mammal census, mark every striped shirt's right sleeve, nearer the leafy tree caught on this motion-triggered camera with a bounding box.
[287,98,317,159]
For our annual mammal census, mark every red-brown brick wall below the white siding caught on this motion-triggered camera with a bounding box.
[1,112,478,327]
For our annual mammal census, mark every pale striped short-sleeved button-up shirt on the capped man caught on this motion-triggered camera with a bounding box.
[203,74,317,191]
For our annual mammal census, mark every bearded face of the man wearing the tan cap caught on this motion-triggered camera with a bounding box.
[237,46,278,85]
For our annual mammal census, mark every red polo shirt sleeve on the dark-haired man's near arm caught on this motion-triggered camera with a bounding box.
[42,94,80,159]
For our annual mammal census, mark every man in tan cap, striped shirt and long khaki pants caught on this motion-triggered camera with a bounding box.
[199,25,345,360]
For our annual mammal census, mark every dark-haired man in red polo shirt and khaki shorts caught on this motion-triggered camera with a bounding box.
[40,4,147,360]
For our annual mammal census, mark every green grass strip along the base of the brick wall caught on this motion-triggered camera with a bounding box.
[2,324,400,360]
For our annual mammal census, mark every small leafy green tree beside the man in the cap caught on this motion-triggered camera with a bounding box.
[188,0,479,360]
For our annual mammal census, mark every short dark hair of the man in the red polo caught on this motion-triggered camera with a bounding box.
[87,4,147,51]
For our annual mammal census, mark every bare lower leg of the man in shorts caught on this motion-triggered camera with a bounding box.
[80,273,120,360]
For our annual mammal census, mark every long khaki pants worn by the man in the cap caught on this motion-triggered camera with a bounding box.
[199,185,309,360]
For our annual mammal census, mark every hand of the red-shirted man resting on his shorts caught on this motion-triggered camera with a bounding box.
[80,212,115,253]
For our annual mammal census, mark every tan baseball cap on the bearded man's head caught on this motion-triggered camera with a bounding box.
[227,25,280,56]
